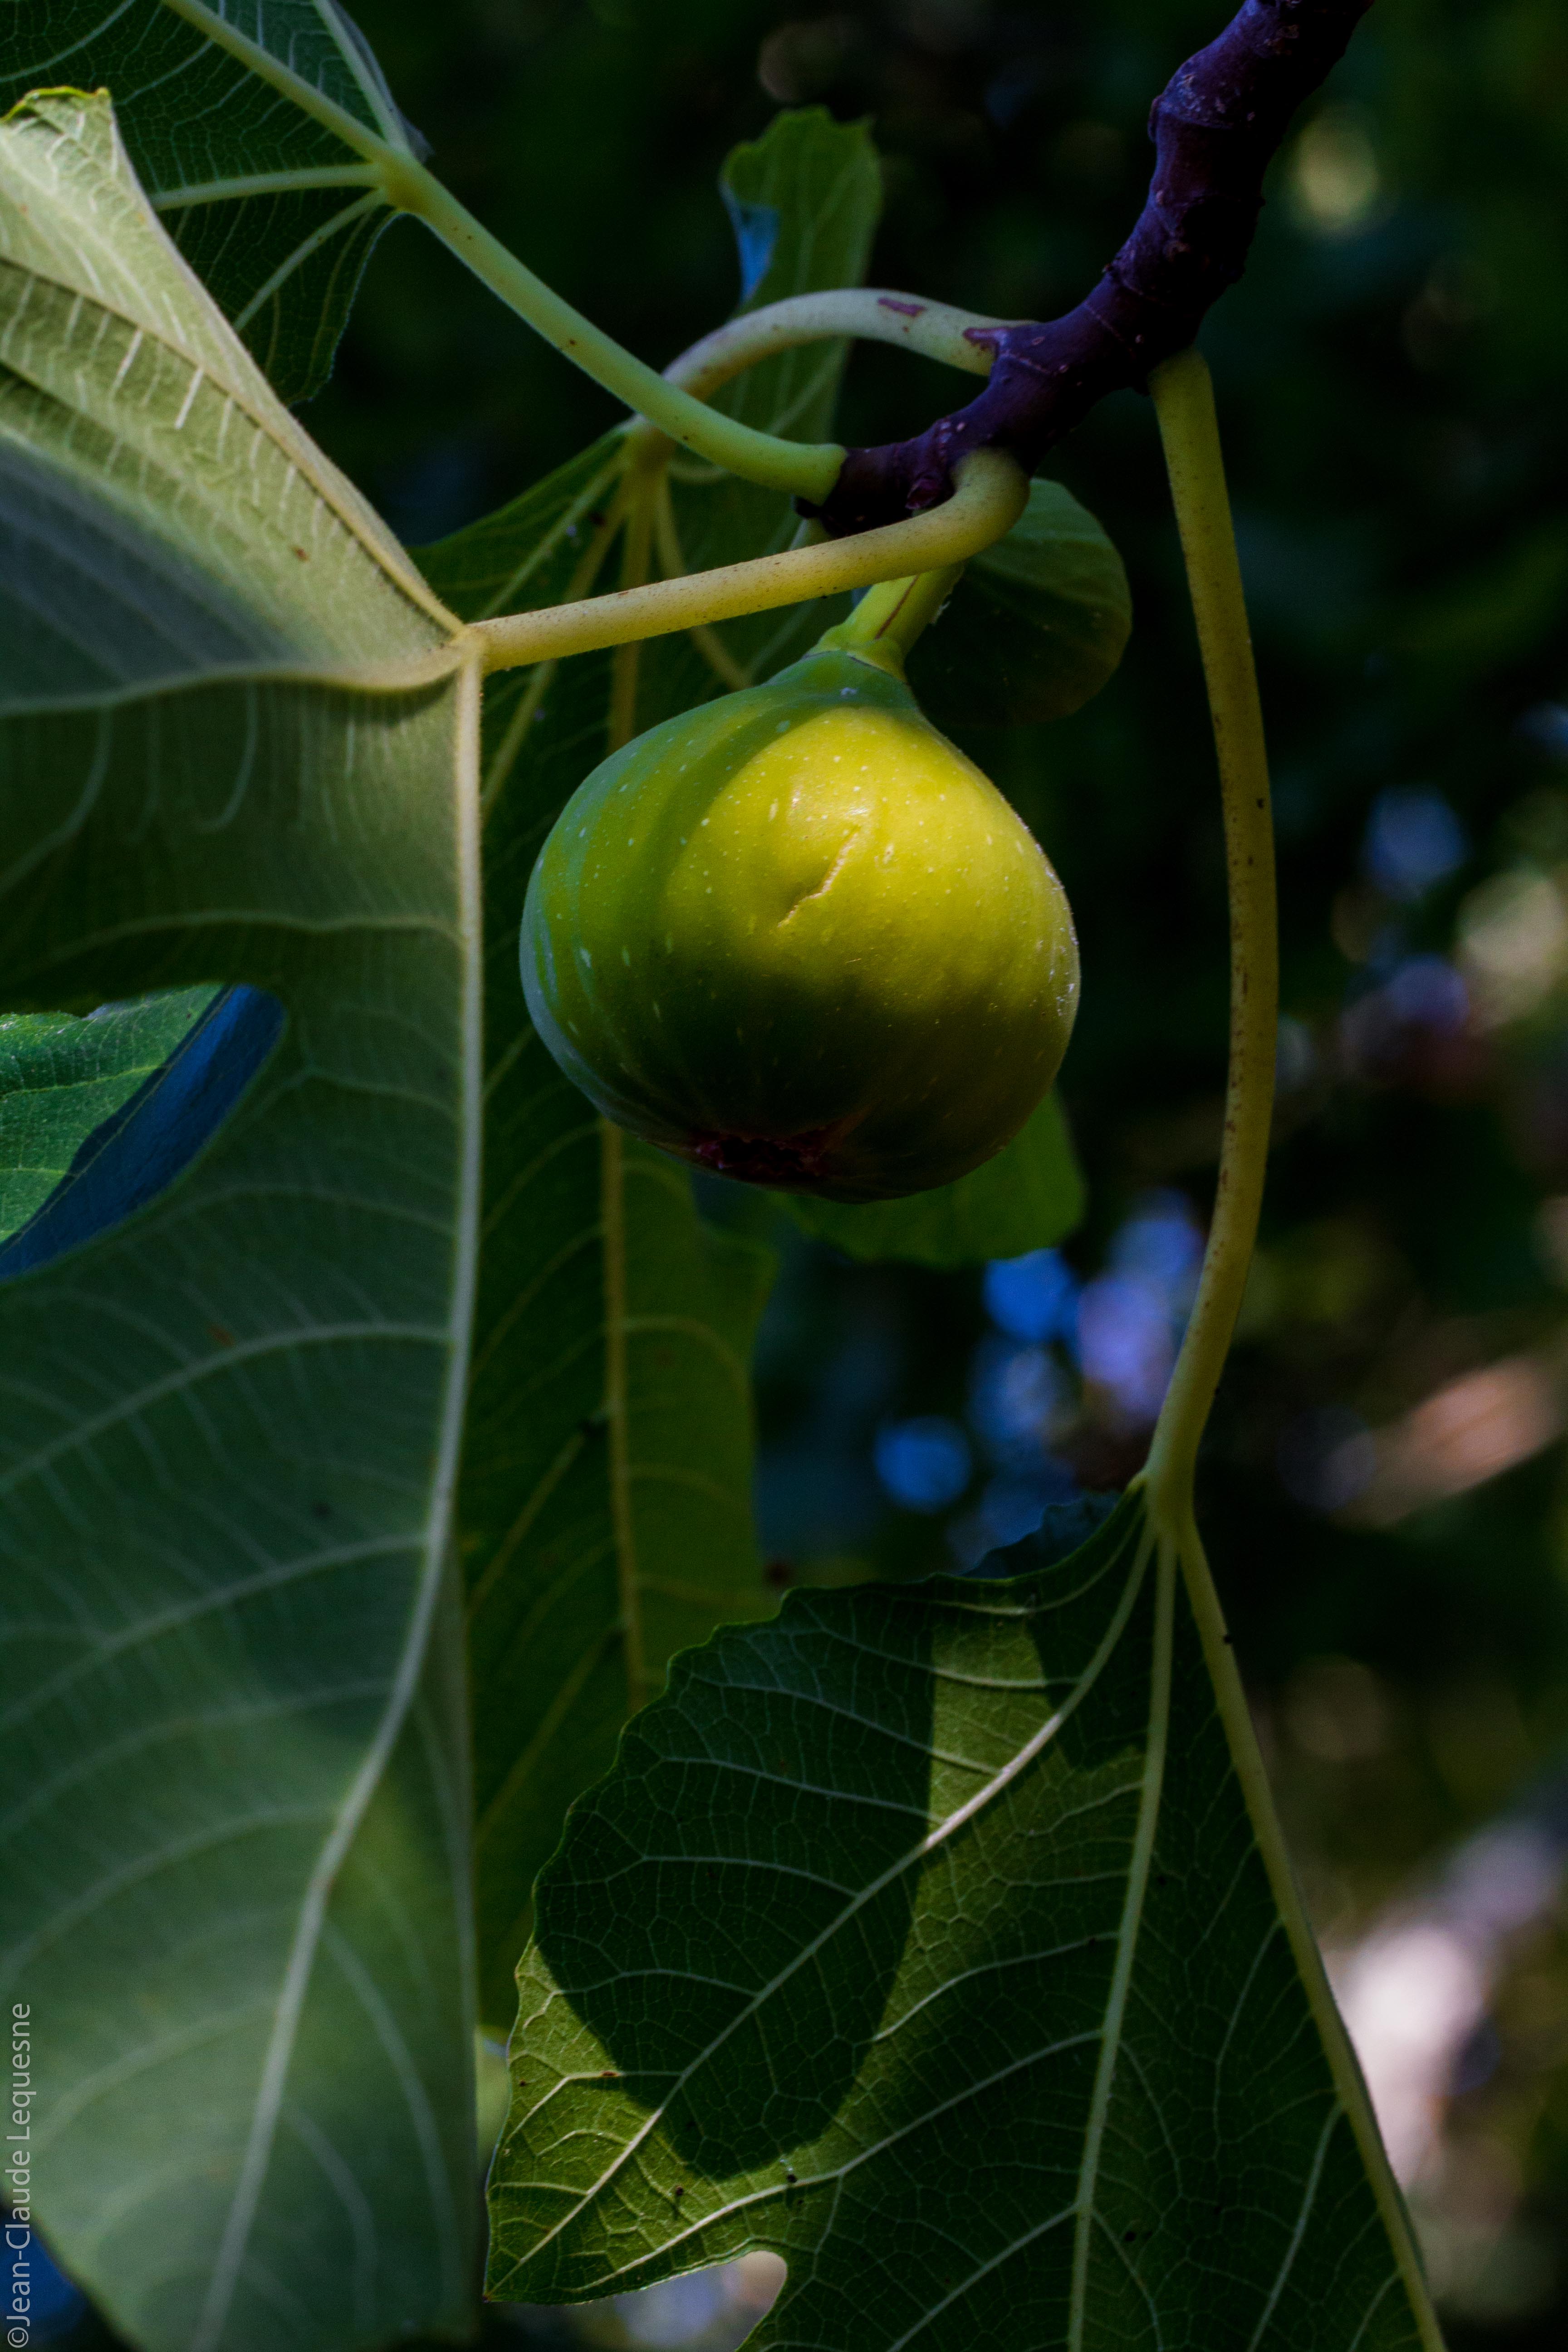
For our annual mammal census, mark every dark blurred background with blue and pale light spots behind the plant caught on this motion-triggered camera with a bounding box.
[40,0,1568,2352]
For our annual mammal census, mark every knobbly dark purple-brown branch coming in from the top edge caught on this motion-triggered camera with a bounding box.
[799,0,1371,539]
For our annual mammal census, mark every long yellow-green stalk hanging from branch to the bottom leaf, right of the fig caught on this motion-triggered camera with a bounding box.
[1142,350,1279,1524]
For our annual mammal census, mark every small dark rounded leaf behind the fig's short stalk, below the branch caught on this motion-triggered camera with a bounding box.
[910,482,1133,727]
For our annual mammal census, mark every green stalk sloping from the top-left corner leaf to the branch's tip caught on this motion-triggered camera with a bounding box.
[381,148,844,501]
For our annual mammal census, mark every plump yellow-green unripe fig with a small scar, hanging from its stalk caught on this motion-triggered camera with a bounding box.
[522,647,1079,1202]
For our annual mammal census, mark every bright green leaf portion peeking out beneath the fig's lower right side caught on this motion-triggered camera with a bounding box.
[778,1094,1084,1268]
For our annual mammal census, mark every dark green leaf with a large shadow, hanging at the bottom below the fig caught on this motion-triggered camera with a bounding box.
[489,1494,1436,2352]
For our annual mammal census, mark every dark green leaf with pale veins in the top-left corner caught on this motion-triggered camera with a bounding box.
[0,0,418,400]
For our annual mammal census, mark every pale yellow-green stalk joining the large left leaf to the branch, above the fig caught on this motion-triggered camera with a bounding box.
[466,449,1029,670]
